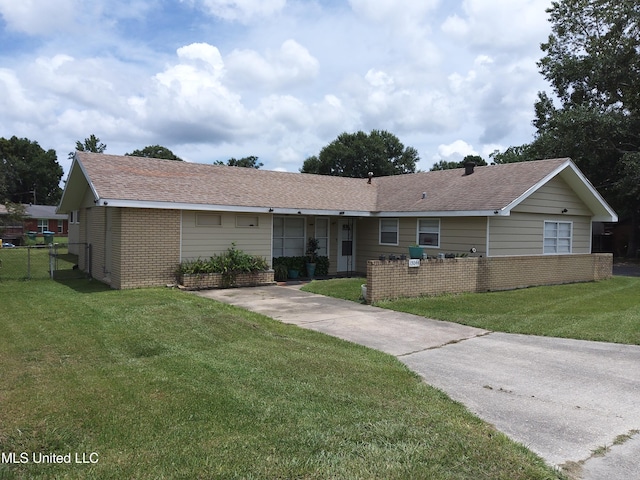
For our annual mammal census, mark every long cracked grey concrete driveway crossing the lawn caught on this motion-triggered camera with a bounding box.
[198,286,640,480]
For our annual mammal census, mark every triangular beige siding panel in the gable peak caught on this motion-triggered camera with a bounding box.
[512,177,592,217]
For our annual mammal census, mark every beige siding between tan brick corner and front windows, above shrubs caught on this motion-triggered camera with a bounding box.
[180,210,273,263]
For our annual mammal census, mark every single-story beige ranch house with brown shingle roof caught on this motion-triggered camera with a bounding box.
[58,152,617,288]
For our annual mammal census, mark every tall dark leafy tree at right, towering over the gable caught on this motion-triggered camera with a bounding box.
[492,0,640,255]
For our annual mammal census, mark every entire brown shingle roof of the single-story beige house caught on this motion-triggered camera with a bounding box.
[76,152,568,212]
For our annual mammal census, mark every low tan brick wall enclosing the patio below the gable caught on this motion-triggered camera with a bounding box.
[367,253,613,303]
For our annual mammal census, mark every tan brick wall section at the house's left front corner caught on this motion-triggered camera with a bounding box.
[111,208,180,289]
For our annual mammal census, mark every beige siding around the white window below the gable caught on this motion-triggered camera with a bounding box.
[488,212,591,257]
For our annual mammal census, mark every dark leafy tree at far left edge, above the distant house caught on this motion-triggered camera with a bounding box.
[0,136,63,205]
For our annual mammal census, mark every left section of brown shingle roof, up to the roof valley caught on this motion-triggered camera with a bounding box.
[76,152,376,211]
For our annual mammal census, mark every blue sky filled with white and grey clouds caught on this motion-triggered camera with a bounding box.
[0,0,551,176]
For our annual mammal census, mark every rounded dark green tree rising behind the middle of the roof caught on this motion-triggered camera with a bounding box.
[300,130,420,178]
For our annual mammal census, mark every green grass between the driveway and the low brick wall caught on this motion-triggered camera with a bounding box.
[304,276,640,345]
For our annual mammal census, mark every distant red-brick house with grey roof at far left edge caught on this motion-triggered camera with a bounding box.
[0,204,69,245]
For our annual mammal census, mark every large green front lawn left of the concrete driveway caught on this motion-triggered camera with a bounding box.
[0,280,558,479]
